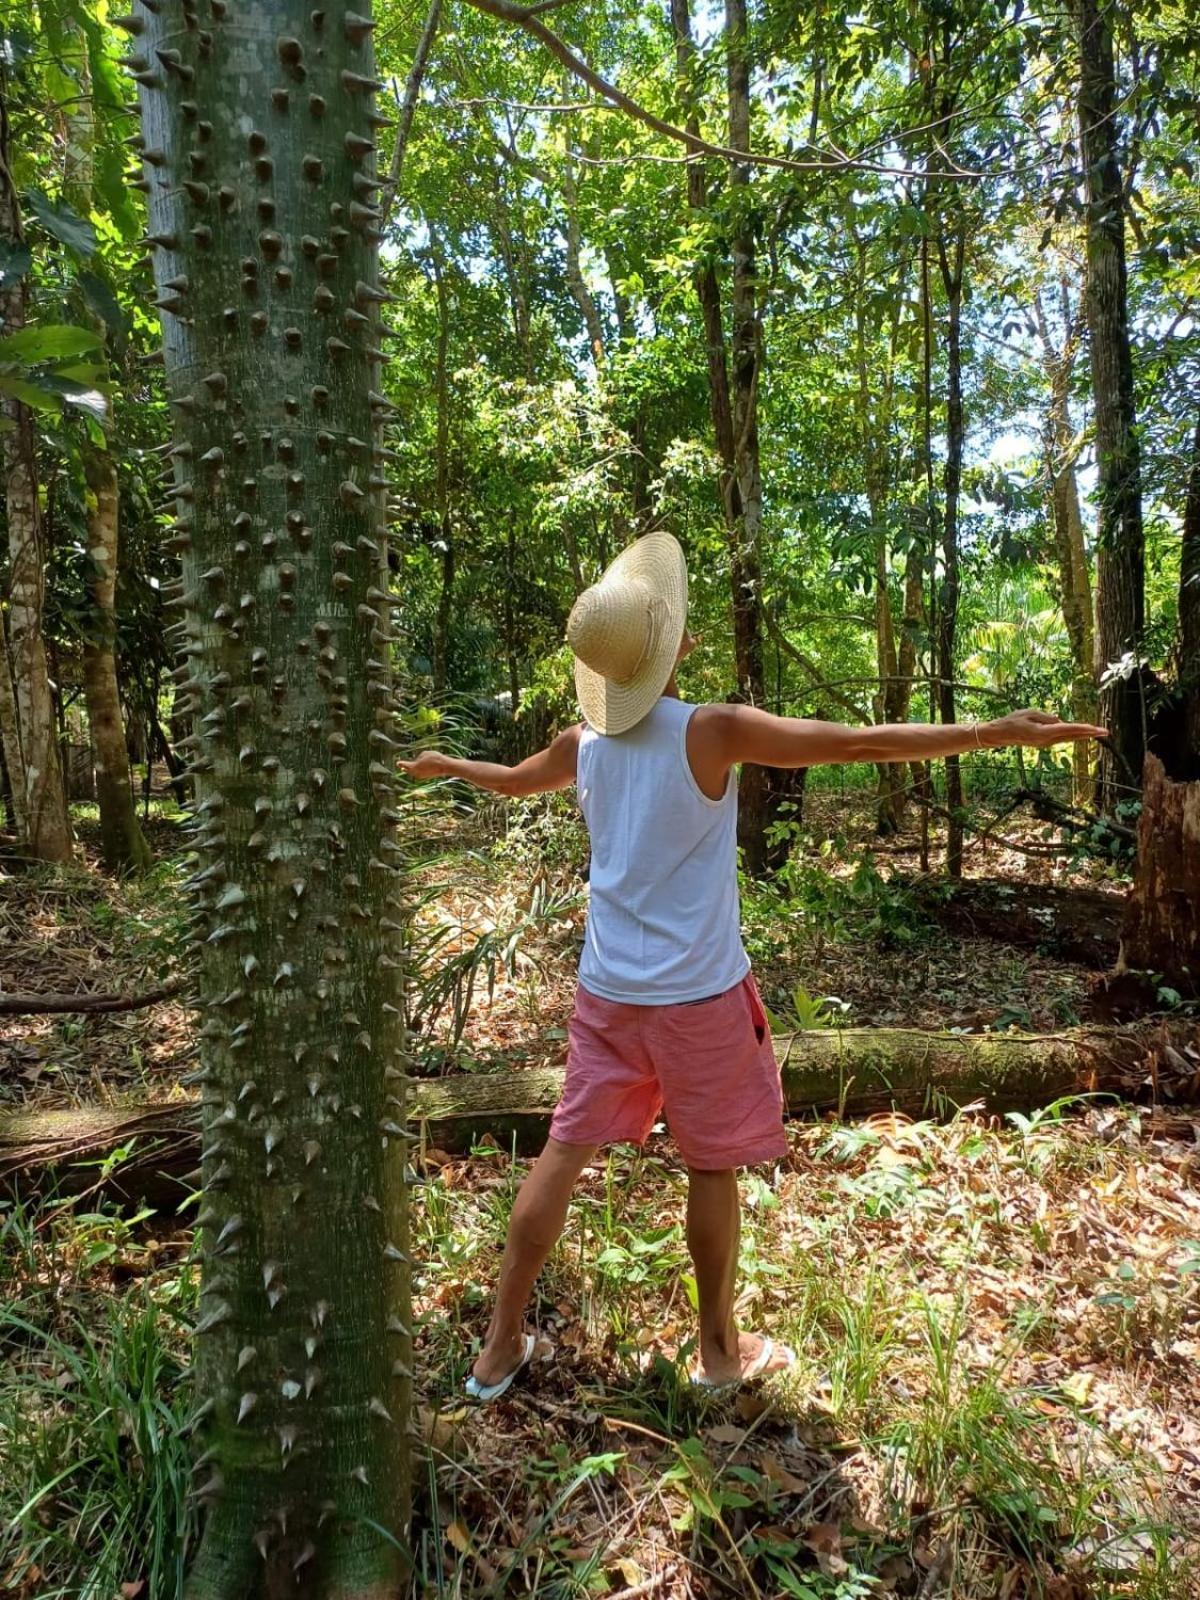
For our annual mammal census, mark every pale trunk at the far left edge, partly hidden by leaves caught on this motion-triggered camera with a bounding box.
[0,90,72,861]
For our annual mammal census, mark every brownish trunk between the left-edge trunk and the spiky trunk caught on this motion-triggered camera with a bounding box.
[83,443,154,872]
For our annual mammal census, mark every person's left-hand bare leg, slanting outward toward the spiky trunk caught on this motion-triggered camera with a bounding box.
[472,1139,597,1384]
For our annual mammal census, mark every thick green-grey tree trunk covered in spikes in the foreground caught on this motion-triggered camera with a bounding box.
[126,0,411,1600]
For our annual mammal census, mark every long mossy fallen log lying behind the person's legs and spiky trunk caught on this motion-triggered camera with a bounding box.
[0,1022,1200,1205]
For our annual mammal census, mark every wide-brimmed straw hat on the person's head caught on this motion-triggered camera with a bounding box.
[566,533,688,733]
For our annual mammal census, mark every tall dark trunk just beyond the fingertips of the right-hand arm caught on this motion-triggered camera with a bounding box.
[1072,0,1146,811]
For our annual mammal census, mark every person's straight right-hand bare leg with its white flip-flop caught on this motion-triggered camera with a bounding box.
[688,1168,790,1384]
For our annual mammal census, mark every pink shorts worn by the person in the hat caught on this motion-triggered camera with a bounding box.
[550,973,787,1171]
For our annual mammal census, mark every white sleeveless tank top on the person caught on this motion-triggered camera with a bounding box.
[578,696,750,1005]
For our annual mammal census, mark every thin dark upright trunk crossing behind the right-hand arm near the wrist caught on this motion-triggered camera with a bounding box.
[938,228,966,878]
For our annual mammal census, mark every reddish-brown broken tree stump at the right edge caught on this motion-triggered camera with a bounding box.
[1117,755,1200,1000]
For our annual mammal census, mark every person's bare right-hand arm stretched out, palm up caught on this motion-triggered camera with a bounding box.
[704,706,1107,766]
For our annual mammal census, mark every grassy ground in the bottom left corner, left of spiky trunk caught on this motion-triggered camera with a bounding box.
[0,1205,194,1600]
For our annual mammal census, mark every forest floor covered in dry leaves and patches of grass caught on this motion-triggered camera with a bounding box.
[0,795,1200,1600]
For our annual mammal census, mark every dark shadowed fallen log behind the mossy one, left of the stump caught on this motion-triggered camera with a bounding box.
[894,878,1125,971]
